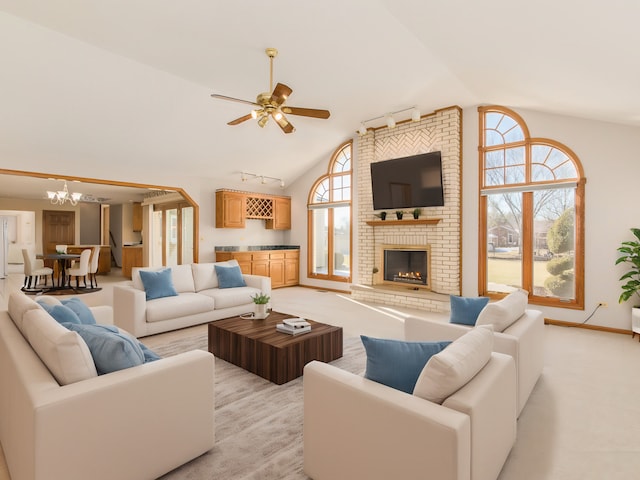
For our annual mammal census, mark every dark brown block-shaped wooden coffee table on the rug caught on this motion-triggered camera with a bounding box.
[209,312,342,385]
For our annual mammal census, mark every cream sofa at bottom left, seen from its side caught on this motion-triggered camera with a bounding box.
[0,293,214,480]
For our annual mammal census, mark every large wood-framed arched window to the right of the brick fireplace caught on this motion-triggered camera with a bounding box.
[478,106,586,309]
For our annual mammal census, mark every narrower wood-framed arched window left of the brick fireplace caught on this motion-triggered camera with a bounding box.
[307,141,352,282]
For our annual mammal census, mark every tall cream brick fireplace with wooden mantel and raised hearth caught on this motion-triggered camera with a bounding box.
[352,107,462,311]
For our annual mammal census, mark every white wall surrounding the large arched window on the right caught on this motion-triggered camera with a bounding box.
[462,107,640,329]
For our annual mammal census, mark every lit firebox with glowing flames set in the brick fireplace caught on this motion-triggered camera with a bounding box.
[382,246,429,288]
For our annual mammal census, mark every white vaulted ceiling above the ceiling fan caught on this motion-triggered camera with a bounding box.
[0,0,640,199]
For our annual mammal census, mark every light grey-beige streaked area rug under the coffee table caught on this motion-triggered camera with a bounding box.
[154,334,366,480]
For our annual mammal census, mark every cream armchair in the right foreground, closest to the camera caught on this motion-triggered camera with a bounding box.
[303,330,516,480]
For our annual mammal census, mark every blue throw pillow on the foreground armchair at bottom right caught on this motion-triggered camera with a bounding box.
[360,335,451,393]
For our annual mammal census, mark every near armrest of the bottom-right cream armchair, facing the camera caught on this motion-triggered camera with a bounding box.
[303,361,471,480]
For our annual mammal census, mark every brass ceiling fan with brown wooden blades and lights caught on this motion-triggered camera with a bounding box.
[211,48,331,133]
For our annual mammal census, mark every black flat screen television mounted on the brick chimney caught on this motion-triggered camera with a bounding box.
[371,152,444,210]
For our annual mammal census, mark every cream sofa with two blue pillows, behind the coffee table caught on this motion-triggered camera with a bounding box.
[113,260,271,337]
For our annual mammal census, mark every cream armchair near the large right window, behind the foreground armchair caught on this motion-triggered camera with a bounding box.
[404,292,544,416]
